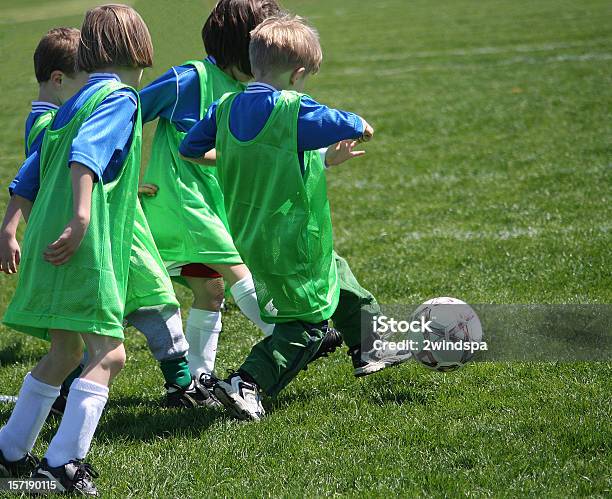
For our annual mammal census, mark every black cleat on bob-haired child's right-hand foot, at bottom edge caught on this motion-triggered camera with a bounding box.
[32,459,99,496]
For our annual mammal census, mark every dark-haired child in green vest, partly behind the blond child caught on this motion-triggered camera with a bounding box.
[140,0,328,386]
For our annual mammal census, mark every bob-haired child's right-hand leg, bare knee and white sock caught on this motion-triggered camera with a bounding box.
[45,334,125,467]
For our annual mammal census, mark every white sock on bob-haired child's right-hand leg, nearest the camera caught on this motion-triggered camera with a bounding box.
[45,378,108,467]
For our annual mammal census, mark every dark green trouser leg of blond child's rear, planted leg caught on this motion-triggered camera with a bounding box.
[238,321,327,396]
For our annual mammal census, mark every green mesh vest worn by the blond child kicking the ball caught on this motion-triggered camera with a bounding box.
[216,91,338,323]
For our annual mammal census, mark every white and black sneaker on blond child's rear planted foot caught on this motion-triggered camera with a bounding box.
[214,373,266,421]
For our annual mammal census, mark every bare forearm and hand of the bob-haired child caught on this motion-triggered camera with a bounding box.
[44,162,95,265]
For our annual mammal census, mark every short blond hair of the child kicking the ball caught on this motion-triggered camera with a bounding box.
[249,15,323,74]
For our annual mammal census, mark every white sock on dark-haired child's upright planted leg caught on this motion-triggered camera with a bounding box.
[185,308,221,378]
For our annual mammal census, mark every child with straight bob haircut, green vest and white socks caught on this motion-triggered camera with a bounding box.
[0,5,163,495]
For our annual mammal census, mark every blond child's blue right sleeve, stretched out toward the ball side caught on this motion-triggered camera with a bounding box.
[297,97,363,151]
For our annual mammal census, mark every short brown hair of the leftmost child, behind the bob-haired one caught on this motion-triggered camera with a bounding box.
[34,28,81,83]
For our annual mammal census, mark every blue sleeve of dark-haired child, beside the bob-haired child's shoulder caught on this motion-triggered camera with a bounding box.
[140,66,200,132]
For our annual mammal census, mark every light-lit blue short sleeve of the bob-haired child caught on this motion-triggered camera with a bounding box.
[68,89,138,178]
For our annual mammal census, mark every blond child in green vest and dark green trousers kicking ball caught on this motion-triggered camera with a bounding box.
[180,16,410,420]
